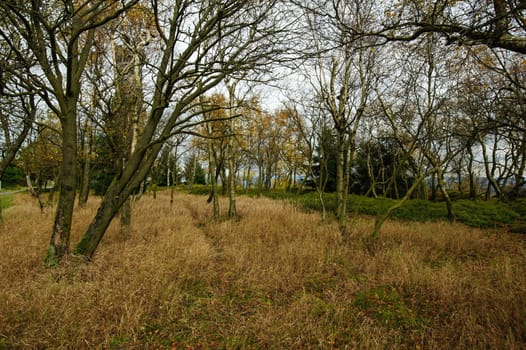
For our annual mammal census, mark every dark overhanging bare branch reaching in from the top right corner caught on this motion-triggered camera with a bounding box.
[350,0,526,53]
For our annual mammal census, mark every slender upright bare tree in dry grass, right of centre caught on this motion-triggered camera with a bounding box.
[304,1,382,235]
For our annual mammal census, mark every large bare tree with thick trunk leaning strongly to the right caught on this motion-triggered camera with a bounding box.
[75,0,288,257]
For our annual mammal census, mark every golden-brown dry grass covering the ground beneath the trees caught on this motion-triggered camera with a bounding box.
[0,194,526,349]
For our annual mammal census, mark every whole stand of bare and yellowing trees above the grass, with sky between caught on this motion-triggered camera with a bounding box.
[0,0,526,265]
